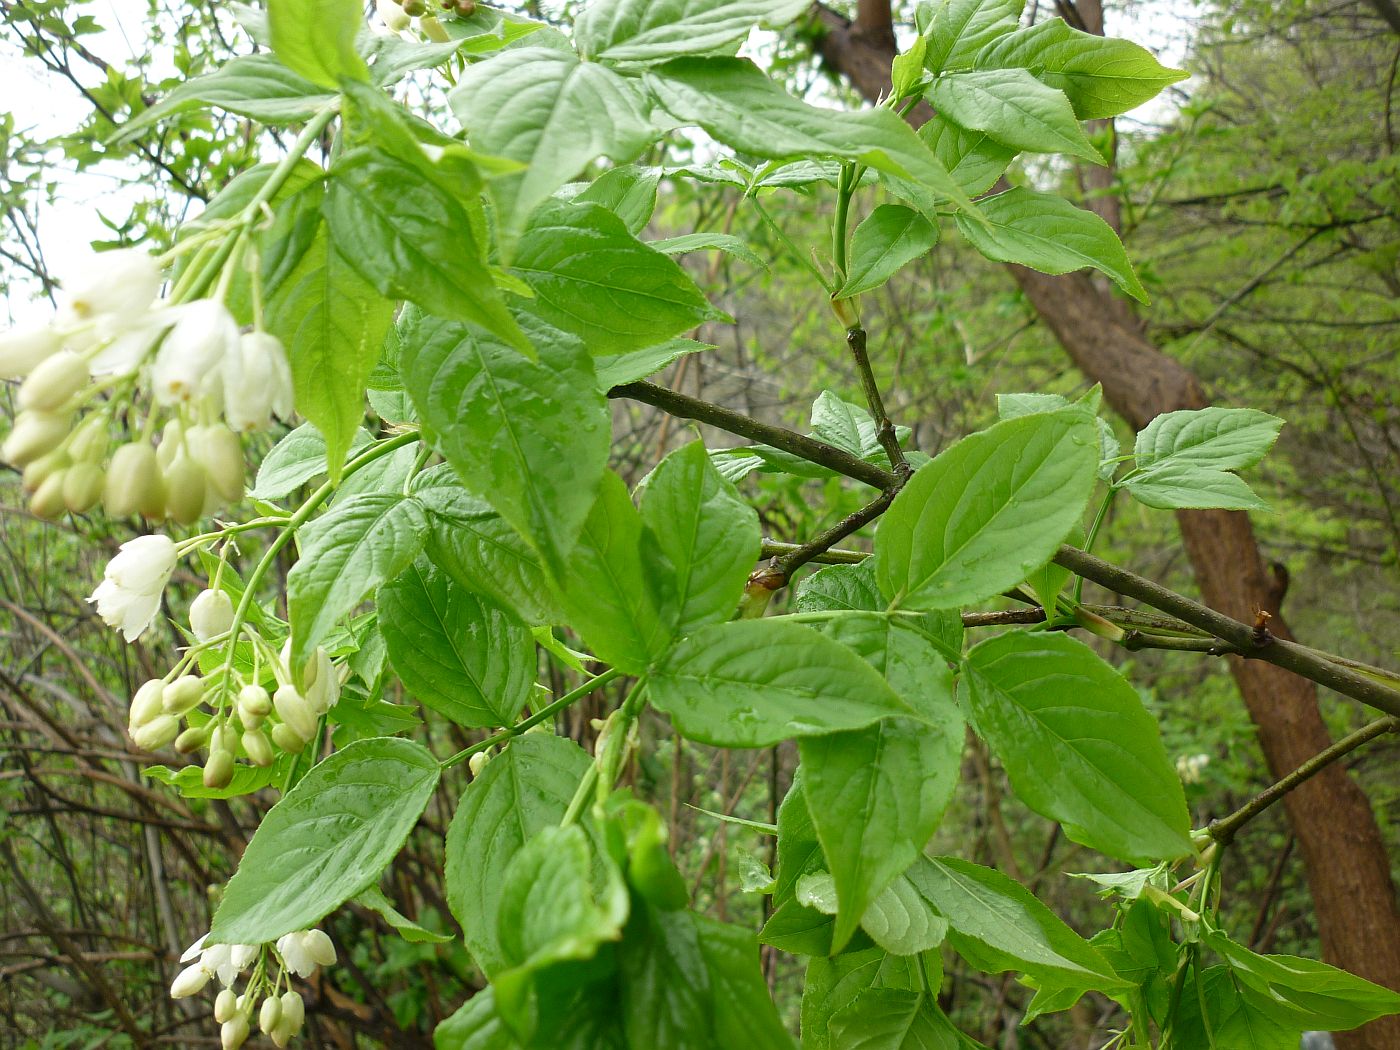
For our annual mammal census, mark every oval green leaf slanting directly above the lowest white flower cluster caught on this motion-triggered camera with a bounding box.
[210,736,438,944]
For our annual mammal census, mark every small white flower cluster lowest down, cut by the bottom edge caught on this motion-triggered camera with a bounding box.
[171,930,336,1050]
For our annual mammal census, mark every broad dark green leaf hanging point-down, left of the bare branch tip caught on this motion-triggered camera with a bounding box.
[402,316,610,577]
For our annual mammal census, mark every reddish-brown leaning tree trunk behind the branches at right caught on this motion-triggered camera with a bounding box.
[818,4,1400,1050]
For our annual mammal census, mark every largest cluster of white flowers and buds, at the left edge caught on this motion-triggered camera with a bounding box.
[0,249,293,525]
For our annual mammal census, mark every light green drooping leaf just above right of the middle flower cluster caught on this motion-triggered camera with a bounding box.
[287,493,427,666]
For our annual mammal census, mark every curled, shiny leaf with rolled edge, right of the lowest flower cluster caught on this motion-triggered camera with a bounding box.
[491,825,627,1033]
